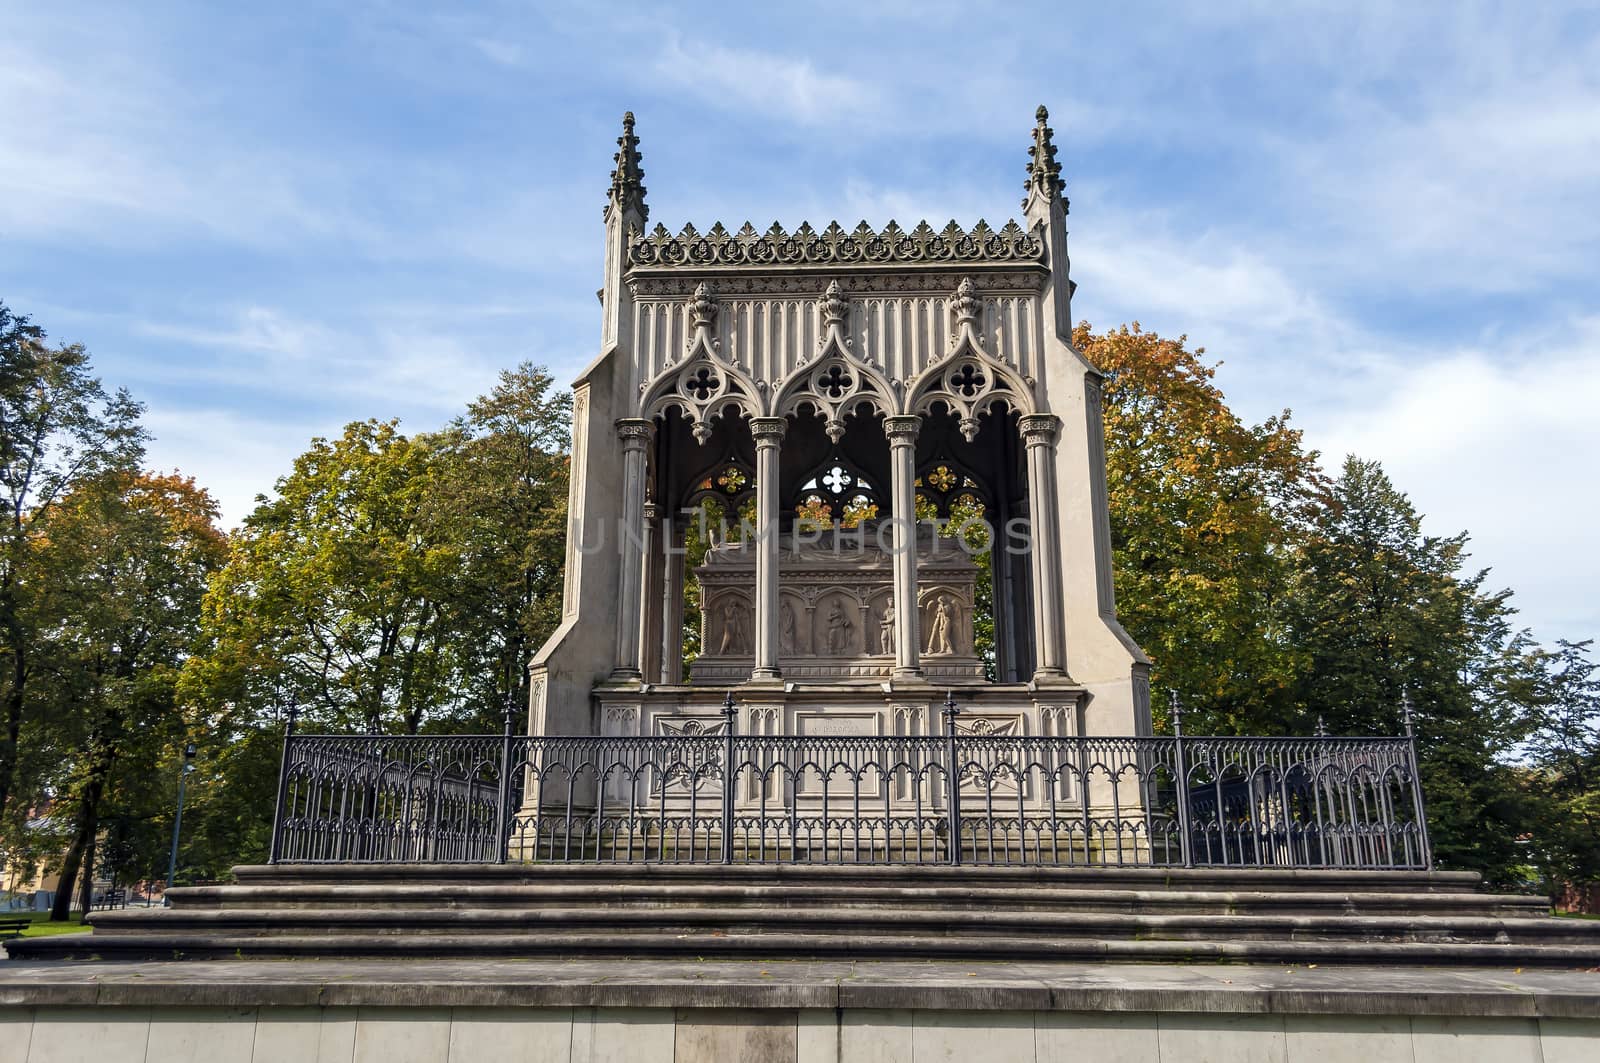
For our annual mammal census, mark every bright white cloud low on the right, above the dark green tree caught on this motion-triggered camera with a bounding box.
[1302,317,1600,640]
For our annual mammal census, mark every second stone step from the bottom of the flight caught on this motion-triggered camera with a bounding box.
[81,906,1600,947]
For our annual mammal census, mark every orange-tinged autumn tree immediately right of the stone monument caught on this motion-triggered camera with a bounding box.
[1074,323,1323,735]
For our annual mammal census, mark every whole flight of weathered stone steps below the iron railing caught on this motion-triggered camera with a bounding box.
[13,864,1600,967]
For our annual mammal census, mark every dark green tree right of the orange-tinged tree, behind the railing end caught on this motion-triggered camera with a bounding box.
[1290,456,1541,882]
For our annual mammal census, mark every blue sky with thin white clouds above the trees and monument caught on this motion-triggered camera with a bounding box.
[0,0,1600,639]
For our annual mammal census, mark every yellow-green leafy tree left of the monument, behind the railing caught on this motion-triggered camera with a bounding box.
[186,421,462,733]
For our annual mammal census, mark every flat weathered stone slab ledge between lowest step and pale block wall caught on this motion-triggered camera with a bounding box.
[0,961,1600,1024]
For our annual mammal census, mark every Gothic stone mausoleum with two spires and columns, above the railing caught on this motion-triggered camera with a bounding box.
[530,107,1150,752]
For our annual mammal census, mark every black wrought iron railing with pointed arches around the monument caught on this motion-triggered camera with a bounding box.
[272,698,1432,869]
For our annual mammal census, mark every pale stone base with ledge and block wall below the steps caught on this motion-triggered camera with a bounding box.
[0,961,1600,1063]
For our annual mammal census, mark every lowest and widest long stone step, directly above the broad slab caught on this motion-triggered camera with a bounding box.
[8,930,1600,969]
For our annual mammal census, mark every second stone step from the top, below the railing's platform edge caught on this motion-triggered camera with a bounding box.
[170,880,1549,917]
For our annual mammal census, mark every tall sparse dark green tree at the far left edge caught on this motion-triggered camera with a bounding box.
[0,303,144,820]
